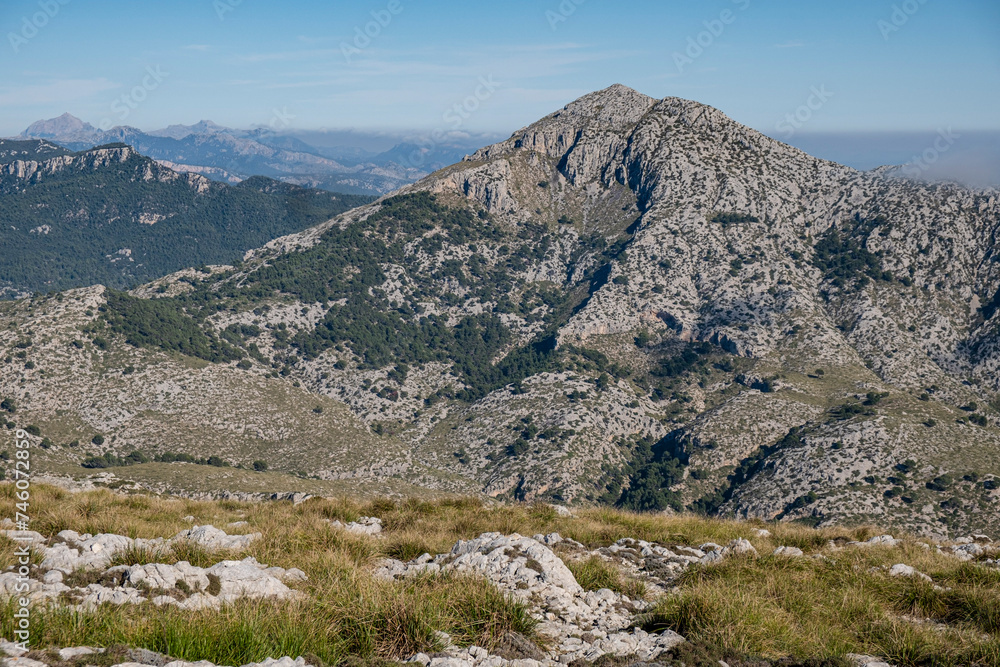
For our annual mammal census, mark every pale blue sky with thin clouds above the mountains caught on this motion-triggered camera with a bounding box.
[0,0,1000,138]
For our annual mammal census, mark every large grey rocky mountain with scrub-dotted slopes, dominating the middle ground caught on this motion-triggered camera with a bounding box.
[0,86,1000,535]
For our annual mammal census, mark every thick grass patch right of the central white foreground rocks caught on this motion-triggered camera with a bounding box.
[642,549,1000,667]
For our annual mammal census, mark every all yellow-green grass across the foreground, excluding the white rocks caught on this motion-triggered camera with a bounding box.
[0,485,1000,667]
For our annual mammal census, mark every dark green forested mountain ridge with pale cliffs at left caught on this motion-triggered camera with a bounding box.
[0,144,370,291]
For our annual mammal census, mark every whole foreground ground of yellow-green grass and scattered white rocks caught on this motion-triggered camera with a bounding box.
[0,484,1000,667]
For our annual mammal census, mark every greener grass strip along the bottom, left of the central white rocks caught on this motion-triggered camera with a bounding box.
[0,569,535,665]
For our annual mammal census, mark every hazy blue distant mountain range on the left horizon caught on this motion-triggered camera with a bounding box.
[21,113,492,195]
